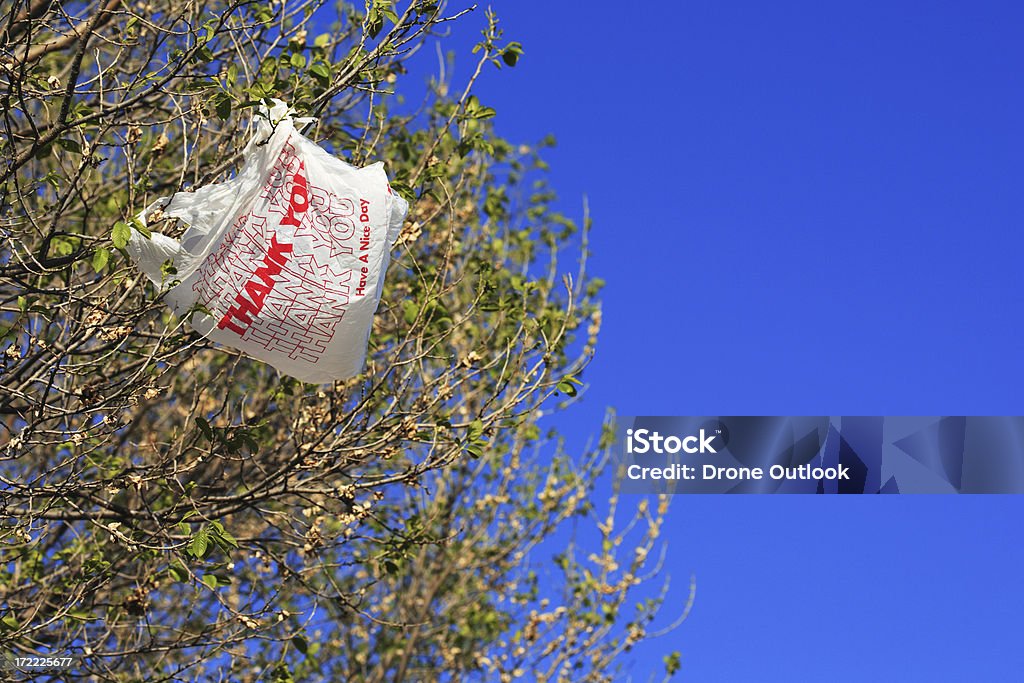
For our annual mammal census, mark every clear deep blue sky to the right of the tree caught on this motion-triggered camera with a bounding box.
[417,0,1024,681]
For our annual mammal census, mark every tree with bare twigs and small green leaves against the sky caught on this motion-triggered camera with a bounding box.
[0,0,678,681]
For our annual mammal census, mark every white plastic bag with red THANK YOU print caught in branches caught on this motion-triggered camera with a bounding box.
[127,100,409,383]
